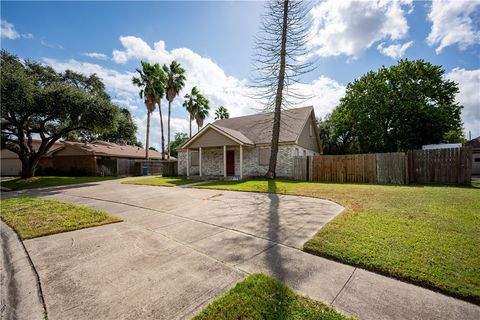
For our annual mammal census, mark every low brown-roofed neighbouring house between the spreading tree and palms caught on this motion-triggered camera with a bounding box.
[53,140,170,175]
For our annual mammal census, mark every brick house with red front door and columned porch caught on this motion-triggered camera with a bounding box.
[177,107,322,179]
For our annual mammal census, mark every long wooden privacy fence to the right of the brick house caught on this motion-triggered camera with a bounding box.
[293,148,472,184]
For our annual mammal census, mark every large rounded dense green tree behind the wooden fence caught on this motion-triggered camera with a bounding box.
[331,60,462,153]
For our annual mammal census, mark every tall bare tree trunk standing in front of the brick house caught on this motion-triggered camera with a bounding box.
[266,0,289,179]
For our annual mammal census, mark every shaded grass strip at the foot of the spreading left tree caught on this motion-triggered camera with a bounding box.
[0,176,116,190]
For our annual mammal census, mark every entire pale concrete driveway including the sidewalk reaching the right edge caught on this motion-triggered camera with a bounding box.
[14,181,480,319]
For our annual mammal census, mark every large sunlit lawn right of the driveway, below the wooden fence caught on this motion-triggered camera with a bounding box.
[197,180,480,304]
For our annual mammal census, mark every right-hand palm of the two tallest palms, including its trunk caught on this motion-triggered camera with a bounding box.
[163,60,186,159]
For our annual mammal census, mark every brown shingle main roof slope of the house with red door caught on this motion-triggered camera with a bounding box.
[212,106,313,144]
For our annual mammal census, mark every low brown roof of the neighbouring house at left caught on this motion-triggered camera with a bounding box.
[55,140,174,159]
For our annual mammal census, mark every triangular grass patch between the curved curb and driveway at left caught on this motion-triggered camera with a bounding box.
[0,197,122,239]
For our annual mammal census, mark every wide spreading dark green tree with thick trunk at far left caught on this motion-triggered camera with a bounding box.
[0,50,117,178]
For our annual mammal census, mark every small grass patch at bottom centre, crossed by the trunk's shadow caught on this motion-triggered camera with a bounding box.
[193,273,352,320]
